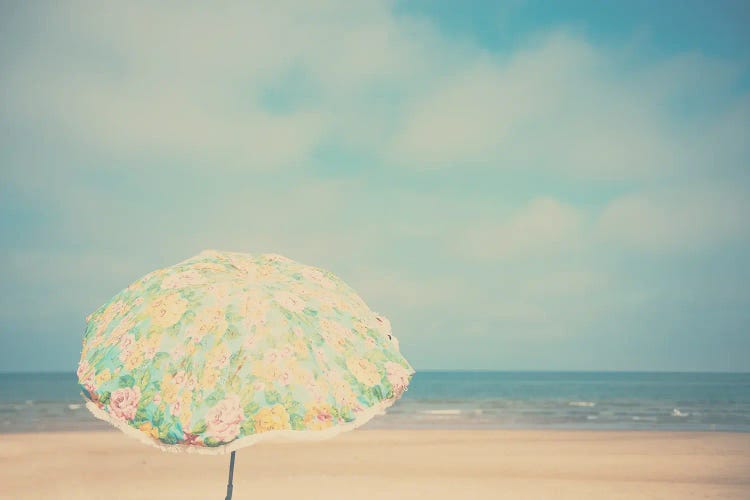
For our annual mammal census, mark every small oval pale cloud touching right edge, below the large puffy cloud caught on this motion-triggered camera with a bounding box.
[597,185,750,253]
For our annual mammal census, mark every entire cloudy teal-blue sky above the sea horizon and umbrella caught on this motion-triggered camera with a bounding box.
[0,0,750,372]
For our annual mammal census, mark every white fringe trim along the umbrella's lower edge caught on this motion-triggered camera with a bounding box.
[86,398,398,455]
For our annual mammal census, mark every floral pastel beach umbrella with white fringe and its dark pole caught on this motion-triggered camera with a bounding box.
[78,250,414,498]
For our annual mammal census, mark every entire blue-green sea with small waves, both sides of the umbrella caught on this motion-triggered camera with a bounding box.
[0,371,750,433]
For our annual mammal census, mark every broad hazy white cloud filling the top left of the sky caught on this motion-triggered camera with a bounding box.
[0,2,449,170]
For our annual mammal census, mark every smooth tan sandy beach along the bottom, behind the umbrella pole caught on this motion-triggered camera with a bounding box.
[0,430,750,499]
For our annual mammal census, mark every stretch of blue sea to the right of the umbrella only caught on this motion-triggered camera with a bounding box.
[370,371,750,432]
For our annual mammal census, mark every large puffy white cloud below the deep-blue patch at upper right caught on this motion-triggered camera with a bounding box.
[389,31,750,179]
